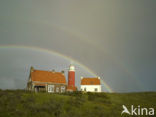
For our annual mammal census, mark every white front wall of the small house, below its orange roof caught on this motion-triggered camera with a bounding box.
[81,85,101,92]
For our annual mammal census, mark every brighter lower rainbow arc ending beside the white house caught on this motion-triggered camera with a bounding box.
[0,45,113,92]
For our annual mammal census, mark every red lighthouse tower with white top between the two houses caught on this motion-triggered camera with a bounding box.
[67,65,76,91]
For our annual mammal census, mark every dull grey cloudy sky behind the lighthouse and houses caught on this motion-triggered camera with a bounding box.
[0,0,156,92]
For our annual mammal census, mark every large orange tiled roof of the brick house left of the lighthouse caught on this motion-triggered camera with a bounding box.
[31,70,66,84]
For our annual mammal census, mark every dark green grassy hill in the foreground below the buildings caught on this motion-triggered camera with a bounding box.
[0,90,156,117]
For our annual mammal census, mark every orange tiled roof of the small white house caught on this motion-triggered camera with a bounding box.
[81,78,100,85]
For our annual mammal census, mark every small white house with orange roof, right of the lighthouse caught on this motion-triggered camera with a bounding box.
[81,77,101,92]
